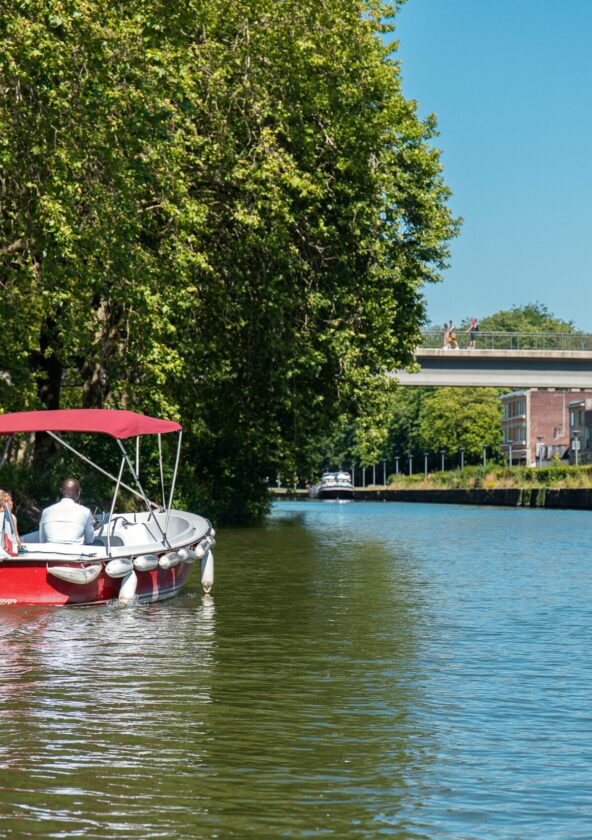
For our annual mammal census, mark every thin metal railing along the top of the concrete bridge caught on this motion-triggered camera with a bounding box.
[418,329,592,351]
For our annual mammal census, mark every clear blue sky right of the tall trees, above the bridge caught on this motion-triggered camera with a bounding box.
[395,0,592,332]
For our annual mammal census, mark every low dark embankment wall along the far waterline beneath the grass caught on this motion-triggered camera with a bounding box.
[271,487,592,510]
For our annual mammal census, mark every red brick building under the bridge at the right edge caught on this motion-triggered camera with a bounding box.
[500,388,592,466]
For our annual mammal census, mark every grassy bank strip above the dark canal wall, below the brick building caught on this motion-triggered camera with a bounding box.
[388,463,592,490]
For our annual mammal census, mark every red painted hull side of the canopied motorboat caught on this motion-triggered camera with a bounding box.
[0,558,191,606]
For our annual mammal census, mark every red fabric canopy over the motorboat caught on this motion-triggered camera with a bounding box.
[0,408,181,438]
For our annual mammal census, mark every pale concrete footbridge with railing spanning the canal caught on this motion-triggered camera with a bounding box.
[392,331,592,390]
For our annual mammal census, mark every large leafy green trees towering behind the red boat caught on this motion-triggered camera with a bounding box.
[0,0,456,518]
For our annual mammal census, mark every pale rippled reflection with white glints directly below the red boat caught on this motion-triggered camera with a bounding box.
[0,594,216,837]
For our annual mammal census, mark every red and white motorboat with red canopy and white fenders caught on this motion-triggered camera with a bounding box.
[0,409,215,606]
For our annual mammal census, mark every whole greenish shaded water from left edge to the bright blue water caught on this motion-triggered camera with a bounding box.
[0,506,426,838]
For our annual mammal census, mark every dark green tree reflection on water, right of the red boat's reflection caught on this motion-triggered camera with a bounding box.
[205,503,434,837]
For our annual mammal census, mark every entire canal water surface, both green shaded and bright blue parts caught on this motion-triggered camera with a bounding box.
[0,502,592,840]
